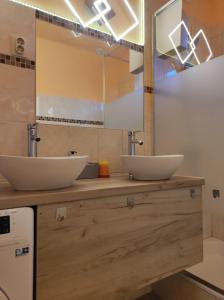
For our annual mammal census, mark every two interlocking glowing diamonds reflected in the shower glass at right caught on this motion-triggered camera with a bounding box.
[168,21,213,65]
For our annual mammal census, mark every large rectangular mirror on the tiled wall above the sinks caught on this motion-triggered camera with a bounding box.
[36,20,144,130]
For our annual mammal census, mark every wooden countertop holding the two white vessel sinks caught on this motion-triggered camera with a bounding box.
[0,175,204,209]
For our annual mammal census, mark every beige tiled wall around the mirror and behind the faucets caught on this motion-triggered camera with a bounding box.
[0,0,151,172]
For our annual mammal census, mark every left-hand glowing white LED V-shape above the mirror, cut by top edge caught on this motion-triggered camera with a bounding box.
[64,0,111,28]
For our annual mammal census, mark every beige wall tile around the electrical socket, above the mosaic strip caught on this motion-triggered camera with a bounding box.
[0,0,35,60]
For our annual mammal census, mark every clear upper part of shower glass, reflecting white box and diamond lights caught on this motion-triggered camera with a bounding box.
[154,0,224,80]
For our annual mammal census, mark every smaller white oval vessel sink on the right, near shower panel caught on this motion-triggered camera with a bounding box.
[121,155,184,180]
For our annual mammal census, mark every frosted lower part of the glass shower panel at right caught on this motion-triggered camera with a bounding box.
[155,56,224,234]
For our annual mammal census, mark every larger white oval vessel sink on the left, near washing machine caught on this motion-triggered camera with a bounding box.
[0,155,88,191]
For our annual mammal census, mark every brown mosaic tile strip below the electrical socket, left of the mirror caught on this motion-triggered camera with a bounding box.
[0,53,36,70]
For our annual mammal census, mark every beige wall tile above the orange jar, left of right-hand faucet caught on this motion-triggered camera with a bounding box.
[99,129,123,172]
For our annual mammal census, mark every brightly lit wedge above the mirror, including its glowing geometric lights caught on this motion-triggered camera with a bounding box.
[8,0,142,45]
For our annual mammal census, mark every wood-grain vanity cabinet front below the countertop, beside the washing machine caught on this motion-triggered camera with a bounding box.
[37,187,202,300]
